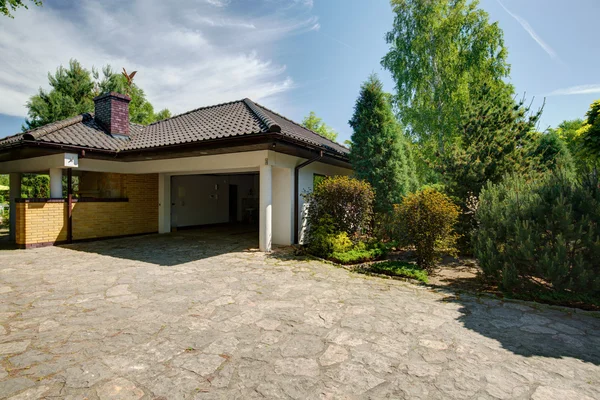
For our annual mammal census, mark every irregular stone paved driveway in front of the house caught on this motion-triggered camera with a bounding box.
[0,231,600,400]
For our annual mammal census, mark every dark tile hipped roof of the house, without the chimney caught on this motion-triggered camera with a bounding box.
[0,99,348,155]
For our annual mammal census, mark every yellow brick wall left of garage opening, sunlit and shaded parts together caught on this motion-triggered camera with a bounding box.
[16,174,158,246]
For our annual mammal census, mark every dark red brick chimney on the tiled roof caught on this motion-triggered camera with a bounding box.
[94,92,131,136]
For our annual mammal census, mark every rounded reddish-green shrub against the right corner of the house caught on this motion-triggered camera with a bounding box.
[305,176,374,247]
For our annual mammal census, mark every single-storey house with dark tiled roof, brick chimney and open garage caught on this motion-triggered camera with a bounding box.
[0,92,352,251]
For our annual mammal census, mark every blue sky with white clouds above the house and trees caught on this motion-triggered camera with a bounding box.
[0,0,600,141]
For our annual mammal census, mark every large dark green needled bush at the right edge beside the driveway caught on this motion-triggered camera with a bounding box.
[474,171,600,296]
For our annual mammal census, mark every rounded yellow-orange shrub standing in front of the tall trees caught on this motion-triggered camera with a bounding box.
[395,188,459,268]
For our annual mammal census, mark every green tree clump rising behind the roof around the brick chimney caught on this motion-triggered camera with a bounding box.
[23,59,170,130]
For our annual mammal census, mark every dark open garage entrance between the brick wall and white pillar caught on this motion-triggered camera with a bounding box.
[171,172,259,241]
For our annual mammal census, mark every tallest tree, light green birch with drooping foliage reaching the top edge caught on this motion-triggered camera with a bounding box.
[381,0,513,158]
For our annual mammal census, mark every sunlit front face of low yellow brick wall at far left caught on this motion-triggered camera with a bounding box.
[16,203,67,245]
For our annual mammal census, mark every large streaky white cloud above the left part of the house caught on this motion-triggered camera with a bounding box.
[0,0,319,116]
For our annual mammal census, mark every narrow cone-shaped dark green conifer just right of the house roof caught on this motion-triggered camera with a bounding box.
[349,74,418,212]
